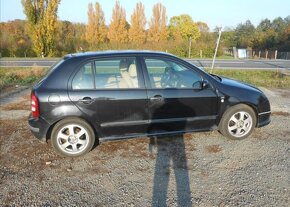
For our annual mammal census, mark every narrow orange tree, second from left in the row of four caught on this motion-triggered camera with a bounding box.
[108,1,128,43]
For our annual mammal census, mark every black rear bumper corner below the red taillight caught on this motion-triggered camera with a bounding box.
[28,114,50,140]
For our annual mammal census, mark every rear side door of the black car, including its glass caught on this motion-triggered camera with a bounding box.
[69,57,148,137]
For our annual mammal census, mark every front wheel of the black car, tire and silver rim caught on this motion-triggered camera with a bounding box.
[219,104,257,140]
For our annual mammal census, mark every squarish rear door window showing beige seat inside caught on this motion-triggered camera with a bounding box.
[95,58,139,89]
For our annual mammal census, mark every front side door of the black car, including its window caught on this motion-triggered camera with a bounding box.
[143,57,217,133]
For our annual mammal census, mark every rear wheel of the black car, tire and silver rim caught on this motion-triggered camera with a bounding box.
[51,118,95,157]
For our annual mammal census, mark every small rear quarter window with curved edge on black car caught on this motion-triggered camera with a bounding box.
[72,62,94,90]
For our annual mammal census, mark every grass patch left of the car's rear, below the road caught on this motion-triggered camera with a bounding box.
[0,67,47,91]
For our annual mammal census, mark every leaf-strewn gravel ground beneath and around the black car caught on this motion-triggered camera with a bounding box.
[0,89,290,207]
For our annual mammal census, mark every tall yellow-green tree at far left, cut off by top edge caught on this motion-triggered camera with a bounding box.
[22,0,60,56]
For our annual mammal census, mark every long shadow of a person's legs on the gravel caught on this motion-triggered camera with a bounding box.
[149,135,192,207]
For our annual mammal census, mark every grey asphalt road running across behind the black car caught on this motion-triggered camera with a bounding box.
[0,59,290,70]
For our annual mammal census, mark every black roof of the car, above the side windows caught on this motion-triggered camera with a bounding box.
[64,50,176,59]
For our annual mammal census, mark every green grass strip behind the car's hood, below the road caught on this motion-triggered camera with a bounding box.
[206,69,290,88]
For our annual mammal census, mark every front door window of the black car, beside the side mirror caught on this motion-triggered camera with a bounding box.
[145,59,202,89]
